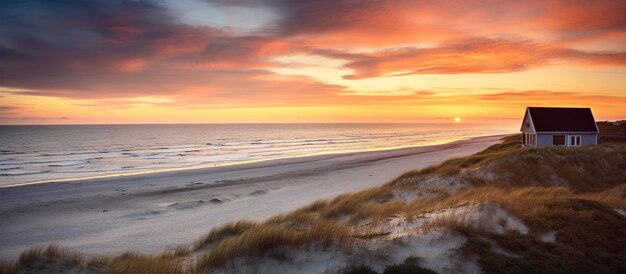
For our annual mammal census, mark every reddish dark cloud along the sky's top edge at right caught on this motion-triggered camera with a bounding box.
[205,0,626,45]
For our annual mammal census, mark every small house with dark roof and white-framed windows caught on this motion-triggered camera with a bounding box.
[520,107,599,147]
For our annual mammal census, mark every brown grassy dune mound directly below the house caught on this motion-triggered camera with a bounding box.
[390,133,626,192]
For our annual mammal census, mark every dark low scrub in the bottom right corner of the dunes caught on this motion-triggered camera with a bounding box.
[460,199,626,273]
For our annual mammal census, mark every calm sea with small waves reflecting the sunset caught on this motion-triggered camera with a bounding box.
[0,123,517,187]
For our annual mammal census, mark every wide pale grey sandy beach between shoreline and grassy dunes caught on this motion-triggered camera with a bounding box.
[0,136,502,260]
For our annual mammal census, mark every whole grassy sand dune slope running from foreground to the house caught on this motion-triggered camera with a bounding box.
[0,124,626,273]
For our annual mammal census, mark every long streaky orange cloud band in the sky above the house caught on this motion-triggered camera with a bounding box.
[318,37,626,79]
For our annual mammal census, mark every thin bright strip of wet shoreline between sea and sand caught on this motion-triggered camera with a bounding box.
[0,134,510,189]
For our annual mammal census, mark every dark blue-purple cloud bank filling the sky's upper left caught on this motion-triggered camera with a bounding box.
[0,1,280,98]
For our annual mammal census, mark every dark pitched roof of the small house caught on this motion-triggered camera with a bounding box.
[528,107,598,132]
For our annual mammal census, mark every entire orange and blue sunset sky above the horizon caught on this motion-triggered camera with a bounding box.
[0,0,626,124]
